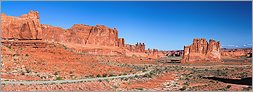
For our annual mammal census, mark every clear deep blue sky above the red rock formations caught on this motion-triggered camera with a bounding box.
[2,2,252,50]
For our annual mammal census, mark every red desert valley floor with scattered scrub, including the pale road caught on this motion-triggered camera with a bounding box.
[1,40,252,91]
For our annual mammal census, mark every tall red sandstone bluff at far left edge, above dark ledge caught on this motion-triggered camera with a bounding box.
[1,11,42,40]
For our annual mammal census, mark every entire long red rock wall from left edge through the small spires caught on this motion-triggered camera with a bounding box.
[1,11,162,58]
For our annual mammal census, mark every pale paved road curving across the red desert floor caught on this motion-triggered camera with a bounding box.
[1,71,151,85]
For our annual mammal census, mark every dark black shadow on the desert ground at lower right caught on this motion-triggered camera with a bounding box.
[204,77,252,86]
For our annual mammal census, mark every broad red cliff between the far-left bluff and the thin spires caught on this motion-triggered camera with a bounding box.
[43,24,120,46]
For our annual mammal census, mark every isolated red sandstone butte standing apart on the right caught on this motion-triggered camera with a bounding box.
[181,38,221,63]
